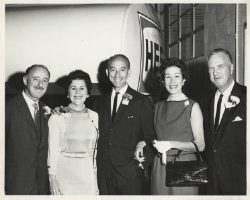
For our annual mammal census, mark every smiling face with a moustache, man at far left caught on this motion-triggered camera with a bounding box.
[23,67,50,101]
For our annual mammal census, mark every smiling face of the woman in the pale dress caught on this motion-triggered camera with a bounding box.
[68,79,88,106]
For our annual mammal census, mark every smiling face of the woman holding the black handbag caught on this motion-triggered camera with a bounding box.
[164,66,185,95]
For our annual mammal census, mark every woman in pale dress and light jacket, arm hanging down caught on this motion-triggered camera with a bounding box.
[48,70,98,195]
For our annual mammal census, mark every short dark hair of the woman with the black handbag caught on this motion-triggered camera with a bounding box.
[159,58,188,82]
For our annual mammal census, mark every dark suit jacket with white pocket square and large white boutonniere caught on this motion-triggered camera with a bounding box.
[203,83,246,195]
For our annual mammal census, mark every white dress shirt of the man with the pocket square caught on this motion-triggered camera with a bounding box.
[214,80,235,124]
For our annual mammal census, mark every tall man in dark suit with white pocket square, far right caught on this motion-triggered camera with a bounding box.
[204,49,247,195]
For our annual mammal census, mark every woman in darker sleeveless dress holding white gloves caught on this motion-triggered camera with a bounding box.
[151,58,205,195]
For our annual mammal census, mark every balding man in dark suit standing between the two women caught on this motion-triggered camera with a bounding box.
[97,54,155,195]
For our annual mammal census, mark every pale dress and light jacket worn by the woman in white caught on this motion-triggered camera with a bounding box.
[48,107,98,195]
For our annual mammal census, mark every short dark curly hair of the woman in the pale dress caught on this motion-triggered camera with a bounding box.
[66,69,92,94]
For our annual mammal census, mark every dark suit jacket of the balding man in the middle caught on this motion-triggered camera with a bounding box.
[97,87,155,191]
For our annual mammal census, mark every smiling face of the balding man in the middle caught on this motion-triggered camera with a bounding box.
[107,57,130,91]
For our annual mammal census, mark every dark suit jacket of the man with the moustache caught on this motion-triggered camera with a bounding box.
[5,95,49,195]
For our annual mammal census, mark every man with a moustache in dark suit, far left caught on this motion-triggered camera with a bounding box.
[5,65,50,195]
